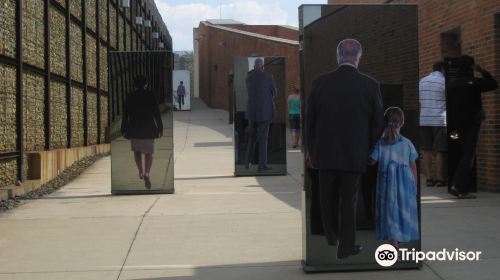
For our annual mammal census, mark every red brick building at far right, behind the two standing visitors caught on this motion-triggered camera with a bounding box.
[328,0,500,192]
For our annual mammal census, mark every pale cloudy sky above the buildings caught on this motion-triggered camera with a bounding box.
[155,0,327,51]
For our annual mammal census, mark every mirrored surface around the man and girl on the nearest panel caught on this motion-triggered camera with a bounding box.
[299,5,421,272]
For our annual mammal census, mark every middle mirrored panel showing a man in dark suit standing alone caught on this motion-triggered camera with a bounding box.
[233,57,287,176]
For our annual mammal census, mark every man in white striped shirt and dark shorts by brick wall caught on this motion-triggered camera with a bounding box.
[419,62,447,187]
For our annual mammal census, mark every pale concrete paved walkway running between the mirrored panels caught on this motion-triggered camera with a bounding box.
[0,101,500,280]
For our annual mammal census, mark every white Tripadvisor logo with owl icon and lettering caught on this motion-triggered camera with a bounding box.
[375,244,482,267]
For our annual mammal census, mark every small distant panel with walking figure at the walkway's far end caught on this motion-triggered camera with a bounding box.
[172,70,191,111]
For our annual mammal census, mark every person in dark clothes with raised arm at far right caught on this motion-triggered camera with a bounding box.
[447,55,498,198]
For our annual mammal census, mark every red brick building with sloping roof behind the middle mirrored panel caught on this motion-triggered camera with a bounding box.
[194,21,300,110]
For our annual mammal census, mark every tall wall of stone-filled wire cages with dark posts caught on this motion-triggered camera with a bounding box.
[0,0,172,187]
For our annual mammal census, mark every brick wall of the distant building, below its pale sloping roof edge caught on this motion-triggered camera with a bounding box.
[198,23,300,110]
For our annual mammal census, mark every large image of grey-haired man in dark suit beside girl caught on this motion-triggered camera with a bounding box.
[306,39,383,259]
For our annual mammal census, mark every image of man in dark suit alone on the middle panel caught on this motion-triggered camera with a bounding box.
[245,58,276,171]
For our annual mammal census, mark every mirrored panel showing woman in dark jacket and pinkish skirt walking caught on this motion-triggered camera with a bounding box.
[109,52,174,194]
